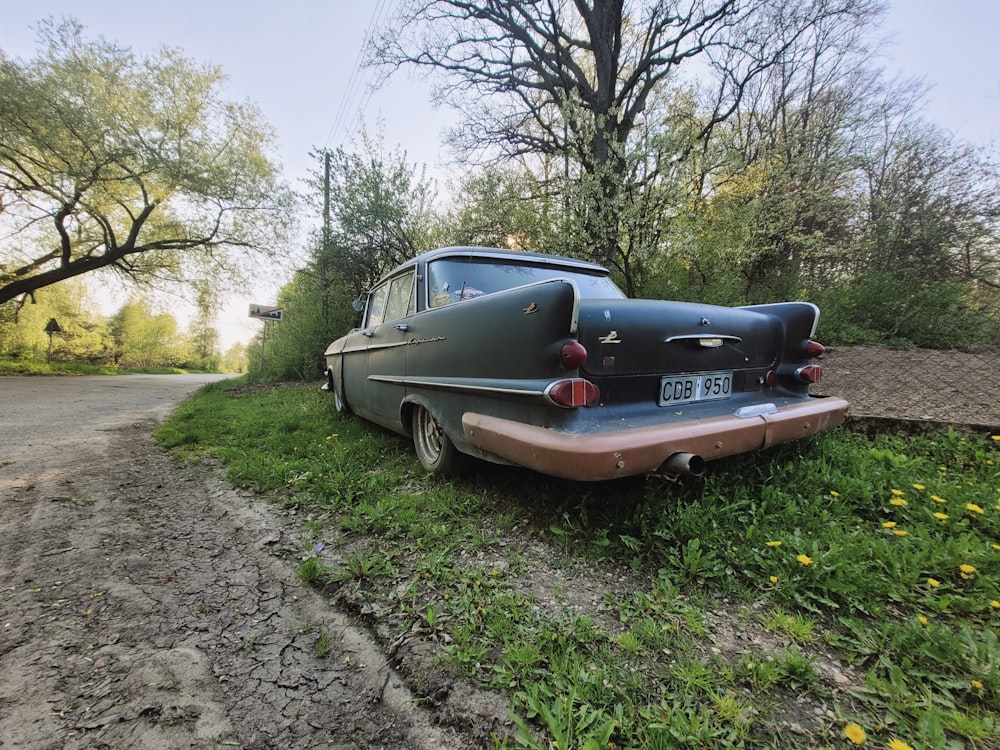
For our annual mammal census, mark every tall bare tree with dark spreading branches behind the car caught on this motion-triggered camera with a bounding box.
[369,0,864,270]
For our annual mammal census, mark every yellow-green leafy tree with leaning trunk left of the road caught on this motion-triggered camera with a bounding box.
[0,21,290,304]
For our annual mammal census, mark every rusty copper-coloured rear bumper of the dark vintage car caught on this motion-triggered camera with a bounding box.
[462,398,848,481]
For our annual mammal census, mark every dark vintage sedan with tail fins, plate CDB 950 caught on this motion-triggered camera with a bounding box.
[323,247,848,481]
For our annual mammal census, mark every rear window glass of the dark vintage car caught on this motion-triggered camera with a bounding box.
[427,258,625,307]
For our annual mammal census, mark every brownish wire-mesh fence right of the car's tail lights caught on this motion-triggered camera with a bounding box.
[813,346,1000,432]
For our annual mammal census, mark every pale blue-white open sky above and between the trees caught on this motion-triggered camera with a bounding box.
[0,0,1000,345]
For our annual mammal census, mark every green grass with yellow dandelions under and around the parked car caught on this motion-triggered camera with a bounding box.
[158,381,1000,750]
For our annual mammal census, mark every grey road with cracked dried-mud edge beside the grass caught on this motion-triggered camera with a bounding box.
[0,375,463,750]
